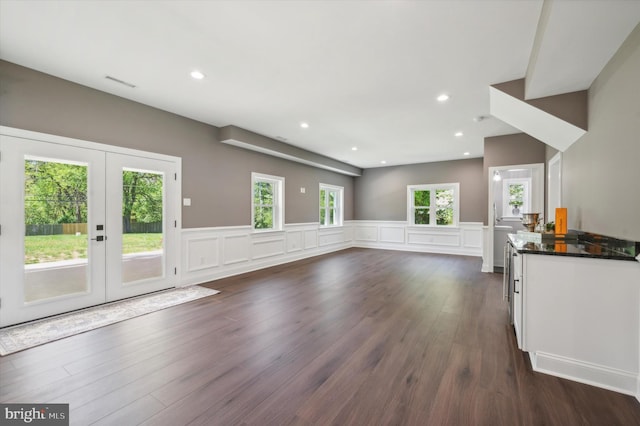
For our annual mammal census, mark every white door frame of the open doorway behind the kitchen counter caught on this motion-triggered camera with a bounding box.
[482,163,545,272]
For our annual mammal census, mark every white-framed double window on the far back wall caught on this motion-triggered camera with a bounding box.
[407,183,460,226]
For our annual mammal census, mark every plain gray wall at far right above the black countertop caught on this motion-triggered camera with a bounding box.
[562,25,640,241]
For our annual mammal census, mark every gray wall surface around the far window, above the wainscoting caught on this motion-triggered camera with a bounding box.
[354,158,487,222]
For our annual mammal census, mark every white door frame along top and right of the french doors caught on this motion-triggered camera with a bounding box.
[0,126,182,326]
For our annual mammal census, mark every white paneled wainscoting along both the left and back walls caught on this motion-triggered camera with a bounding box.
[180,220,483,286]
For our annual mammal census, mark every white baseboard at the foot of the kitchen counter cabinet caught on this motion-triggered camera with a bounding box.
[529,352,640,401]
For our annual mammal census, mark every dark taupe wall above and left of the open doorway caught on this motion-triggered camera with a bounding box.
[482,133,547,225]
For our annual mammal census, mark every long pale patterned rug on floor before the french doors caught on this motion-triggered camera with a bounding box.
[0,285,220,356]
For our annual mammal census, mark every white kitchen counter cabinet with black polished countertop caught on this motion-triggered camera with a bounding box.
[509,231,640,400]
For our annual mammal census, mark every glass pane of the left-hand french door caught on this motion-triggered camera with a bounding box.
[23,156,89,303]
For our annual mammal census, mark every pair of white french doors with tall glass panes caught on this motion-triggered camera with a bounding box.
[0,135,179,326]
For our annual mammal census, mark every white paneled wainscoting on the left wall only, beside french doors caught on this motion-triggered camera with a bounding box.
[180,223,353,286]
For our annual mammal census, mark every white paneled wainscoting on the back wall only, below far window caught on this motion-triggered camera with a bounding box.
[351,220,483,256]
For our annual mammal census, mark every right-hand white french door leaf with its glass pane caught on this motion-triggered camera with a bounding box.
[106,153,177,301]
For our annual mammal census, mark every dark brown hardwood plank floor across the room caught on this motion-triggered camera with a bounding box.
[0,249,640,426]
